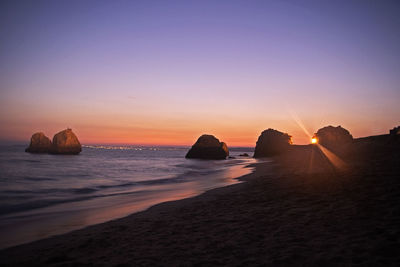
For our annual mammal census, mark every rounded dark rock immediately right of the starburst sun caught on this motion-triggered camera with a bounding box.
[315,126,353,150]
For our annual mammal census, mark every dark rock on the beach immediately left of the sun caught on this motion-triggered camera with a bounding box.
[254,128,292,158]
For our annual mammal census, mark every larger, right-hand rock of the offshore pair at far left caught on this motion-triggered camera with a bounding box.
[51,129,82,154]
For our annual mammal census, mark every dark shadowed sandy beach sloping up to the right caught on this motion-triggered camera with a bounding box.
[0,137,400,266]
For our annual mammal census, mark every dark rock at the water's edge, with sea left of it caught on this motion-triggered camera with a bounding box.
[186,134,229,159]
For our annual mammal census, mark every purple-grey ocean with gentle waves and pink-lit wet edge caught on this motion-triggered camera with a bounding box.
[0,145,255,248]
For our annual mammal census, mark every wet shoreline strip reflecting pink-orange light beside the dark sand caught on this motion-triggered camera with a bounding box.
[0,157,252,251]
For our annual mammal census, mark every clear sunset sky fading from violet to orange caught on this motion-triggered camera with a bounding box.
[0,0,400,146]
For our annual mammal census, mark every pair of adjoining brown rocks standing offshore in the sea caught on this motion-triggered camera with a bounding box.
[25,129,82,155]
